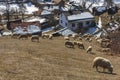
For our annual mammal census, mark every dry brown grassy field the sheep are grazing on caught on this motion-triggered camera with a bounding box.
[0,37,120,80]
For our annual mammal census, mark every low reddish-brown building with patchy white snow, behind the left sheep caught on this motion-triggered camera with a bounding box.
[11,21,41,34]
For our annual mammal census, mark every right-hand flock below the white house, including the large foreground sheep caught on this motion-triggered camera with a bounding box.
[64,34,113,73]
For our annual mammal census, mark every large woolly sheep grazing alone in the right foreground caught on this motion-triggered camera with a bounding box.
[93,57,113,73]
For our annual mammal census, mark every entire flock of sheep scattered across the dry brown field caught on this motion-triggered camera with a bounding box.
[3,31,113,73]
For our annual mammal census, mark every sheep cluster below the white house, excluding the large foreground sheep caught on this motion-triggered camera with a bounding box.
[64,34,112,53]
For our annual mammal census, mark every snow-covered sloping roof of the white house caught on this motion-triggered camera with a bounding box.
[67,12,94,21]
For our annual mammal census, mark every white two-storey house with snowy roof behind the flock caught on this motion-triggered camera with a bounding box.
[59,11,94,32]
